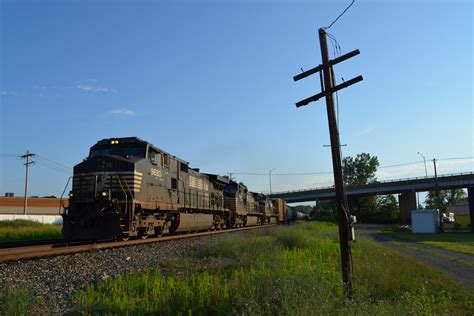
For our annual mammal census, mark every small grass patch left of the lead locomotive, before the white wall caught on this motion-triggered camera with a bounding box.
[0,219,62,242]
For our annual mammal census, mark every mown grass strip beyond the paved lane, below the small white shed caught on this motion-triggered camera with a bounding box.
[383,232,474,256]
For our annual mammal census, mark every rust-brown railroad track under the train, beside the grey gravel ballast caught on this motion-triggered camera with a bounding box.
[0,224,276,263]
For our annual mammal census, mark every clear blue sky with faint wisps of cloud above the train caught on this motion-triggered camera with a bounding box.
[0,0,474,195]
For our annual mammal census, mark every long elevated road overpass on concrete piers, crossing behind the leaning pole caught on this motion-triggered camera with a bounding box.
[270,172,474,225]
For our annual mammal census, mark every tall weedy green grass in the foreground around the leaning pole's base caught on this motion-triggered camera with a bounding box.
[71,223,474,315]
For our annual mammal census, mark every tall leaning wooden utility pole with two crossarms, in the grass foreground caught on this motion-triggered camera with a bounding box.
[293,28,363,298]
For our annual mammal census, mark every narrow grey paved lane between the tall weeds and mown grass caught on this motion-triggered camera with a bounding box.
[356,225,474,290]
